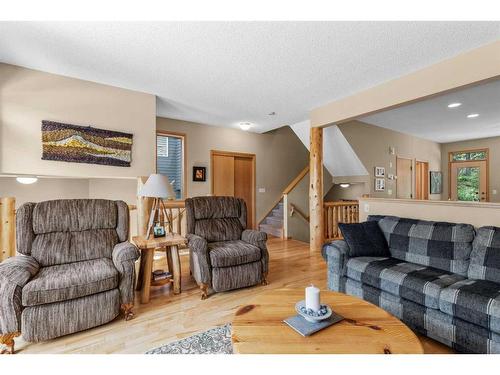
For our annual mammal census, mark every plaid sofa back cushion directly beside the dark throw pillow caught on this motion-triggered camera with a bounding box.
[378,216,475,276]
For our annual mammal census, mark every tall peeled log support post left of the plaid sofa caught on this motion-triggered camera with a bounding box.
[309,127,325,252]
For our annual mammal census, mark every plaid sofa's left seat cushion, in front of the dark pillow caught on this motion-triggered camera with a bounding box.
[347,257,464,309]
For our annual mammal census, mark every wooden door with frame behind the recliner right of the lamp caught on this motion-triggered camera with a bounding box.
[210,150,256,228]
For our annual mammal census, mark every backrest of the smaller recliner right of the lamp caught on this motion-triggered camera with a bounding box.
[186,197,247,242]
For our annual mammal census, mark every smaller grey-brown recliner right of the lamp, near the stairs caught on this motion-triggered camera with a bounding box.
[186,197,269,299]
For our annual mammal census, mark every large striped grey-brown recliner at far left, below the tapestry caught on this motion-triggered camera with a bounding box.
[0,199,140,353]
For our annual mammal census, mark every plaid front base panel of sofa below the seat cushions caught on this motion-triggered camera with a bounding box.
[343,278,500,354]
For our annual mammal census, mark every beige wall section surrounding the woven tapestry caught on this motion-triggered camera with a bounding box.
[0,64,156,177]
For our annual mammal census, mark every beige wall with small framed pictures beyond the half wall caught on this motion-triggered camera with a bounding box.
[339,121,441,199]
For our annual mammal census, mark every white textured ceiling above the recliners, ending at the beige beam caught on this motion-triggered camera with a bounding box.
[0,22,500,132]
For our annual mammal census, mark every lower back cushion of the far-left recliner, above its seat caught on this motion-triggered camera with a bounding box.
[31,229,118,266]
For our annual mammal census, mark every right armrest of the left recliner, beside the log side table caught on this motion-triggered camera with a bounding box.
[113,241,141,305]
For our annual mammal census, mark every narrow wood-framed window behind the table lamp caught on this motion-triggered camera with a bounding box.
[156,132,185,199]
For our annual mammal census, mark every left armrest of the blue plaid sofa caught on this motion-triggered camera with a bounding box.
[322,240,350,292]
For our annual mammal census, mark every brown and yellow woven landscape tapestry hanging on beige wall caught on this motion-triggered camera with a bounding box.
[42,120,133,167]
